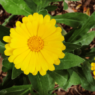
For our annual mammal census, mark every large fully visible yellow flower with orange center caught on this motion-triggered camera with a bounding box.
[3,13,66,75]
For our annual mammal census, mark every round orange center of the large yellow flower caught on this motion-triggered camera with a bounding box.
[28,36,44,52]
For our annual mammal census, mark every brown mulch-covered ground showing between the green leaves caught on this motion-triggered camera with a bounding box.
[0,0,95,95]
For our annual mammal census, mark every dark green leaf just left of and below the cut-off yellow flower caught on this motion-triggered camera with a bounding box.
[75,62,95,91]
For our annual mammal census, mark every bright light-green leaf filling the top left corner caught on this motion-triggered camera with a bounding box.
[0,0,32,16]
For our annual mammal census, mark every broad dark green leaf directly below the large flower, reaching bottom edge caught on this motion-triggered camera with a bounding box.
[28,74,54,95]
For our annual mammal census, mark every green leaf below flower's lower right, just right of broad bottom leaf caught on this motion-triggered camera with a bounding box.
[48,70,68,87]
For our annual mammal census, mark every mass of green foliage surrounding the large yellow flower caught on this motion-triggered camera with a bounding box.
[0,0,95,95]
